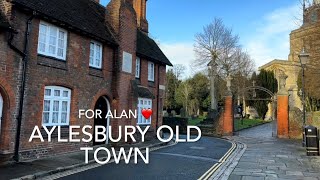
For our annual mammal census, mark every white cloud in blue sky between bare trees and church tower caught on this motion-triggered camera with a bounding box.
[243,4,301,66]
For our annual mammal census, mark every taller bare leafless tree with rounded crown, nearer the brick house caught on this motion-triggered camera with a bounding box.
[194,18,239,110]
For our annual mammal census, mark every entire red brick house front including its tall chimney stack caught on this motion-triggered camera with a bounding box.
[0,0,166,159]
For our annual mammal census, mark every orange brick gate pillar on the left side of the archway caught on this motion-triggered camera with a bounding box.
[222,95,233,136]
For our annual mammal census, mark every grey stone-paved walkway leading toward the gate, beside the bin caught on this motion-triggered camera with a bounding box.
[229,124,320,180]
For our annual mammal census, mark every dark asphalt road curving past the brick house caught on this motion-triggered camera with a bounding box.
[60,137,231,180]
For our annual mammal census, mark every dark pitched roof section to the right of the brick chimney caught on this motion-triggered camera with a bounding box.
[137,30,172,66]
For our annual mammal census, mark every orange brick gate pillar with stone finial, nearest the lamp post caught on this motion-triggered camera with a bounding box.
[277,73,289,138]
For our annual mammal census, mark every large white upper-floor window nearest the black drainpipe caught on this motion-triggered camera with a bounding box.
[38,21,67,60]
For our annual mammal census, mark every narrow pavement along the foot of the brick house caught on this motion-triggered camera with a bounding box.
[0,139,167,180]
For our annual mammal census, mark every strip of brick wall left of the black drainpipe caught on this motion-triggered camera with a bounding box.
[0,32,21,159]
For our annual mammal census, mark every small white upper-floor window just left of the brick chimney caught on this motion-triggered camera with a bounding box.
[89,41,102,69]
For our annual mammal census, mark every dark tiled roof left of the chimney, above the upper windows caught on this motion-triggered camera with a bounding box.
[13,0,116,44]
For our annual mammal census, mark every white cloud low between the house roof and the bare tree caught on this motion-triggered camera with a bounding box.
[160,42,196,78]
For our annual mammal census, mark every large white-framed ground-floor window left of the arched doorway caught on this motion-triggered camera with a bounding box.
[42,86,71,126]
